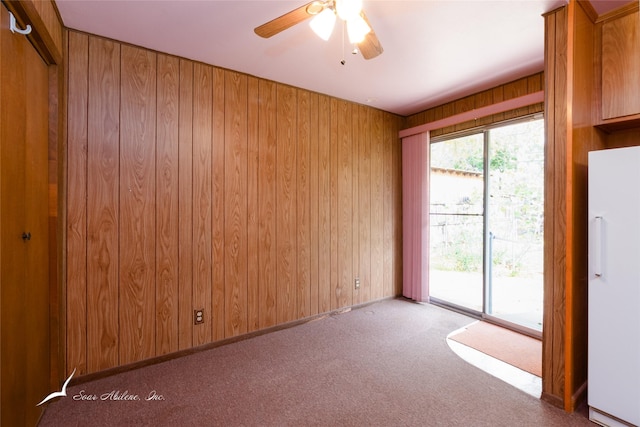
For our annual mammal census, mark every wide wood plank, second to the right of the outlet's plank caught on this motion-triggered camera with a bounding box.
[224,71,248,337]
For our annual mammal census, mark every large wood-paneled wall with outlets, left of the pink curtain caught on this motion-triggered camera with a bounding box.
[66,31,402,375]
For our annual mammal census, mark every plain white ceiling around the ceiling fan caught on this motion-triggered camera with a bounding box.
[56,0,637,115]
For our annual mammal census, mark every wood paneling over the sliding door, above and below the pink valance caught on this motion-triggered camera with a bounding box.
[405,72,544,138]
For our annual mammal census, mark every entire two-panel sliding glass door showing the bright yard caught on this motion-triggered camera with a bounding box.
[429,116,544,337]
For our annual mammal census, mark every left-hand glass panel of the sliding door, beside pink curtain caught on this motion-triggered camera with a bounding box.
[429,133,484,312]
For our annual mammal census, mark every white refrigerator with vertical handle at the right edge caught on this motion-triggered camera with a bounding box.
[587,147,640,426]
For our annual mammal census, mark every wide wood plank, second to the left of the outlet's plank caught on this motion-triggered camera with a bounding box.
[156,54,180,355]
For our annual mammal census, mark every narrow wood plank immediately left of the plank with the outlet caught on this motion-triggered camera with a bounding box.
[178,59,194,350]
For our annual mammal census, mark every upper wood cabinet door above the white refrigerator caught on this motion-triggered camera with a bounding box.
[602,7,640,120]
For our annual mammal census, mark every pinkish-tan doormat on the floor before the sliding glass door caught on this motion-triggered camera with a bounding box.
[449,322,542,377]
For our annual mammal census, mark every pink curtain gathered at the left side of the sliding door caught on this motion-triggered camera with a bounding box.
[402,132,429,302]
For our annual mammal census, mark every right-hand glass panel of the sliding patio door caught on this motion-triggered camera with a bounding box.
[485,119,544,331]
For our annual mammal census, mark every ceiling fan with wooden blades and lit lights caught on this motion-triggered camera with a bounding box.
[254,0,383,59]
